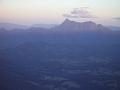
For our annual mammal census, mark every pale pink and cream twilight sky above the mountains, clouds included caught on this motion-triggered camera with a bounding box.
[0,0,120,26]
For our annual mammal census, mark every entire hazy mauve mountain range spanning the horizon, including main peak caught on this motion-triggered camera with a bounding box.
[0,19,120,33]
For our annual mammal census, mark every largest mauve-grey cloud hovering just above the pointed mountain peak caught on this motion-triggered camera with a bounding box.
[63,7,96,18]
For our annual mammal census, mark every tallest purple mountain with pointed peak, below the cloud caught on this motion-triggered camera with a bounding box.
[53,19,111,32]
